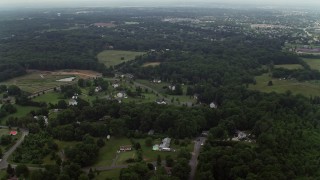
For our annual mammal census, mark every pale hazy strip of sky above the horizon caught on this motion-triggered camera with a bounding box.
[0,0,320,9]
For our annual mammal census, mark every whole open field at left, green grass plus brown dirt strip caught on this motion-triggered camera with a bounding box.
[0,70,100,93]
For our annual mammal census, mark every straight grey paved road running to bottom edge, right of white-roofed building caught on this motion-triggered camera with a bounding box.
[189,137,206,180]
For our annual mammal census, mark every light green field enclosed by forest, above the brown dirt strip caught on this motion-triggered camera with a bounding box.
[97,50,144,67]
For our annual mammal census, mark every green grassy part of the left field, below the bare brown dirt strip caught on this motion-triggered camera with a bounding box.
[0,71,72,93]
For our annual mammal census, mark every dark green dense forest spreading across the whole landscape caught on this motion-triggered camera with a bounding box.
[0,9,320,180]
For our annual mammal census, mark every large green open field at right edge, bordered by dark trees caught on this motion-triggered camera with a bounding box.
[249,74,320,97]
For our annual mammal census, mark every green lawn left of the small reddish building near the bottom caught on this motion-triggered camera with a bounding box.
[93,137,134,167]
